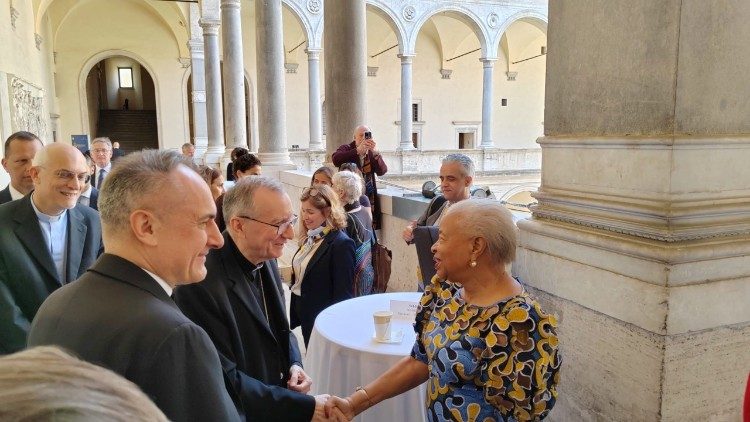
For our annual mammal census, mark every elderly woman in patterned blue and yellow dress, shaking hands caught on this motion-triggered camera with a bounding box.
[326,200,561,421]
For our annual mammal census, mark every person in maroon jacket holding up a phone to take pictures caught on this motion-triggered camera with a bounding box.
[331,125,388,230]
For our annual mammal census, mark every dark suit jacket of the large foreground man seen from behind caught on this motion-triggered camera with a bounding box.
[29,254,240,422]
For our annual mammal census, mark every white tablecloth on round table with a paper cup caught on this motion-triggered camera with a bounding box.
[305,293,425,422]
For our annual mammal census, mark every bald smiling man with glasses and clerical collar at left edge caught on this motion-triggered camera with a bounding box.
[0,143,103,354]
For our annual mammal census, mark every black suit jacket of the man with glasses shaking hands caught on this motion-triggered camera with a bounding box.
[175,232,315,422]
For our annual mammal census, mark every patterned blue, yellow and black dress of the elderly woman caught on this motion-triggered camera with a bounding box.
[411,277,561,422]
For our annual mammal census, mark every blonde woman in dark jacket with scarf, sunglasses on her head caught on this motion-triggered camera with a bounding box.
[289,185,355,346]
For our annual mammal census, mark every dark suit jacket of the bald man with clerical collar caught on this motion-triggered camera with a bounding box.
[0,195,103,354]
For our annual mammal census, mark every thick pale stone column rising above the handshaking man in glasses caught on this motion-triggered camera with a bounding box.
[255,0,292,167]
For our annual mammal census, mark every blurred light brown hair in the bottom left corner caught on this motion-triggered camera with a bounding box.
[0,346,167,422]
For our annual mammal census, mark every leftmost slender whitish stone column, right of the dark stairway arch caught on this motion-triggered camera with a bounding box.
[188,3,208,158]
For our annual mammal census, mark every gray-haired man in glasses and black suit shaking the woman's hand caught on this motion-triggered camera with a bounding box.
[175,176,327,422]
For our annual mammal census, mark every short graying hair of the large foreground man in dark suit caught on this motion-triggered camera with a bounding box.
[99,150,196,231]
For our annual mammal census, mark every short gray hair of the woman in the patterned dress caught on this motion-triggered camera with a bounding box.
[443,199,518,264]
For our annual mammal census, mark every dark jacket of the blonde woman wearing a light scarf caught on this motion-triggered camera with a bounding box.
[289,230,355,344]
